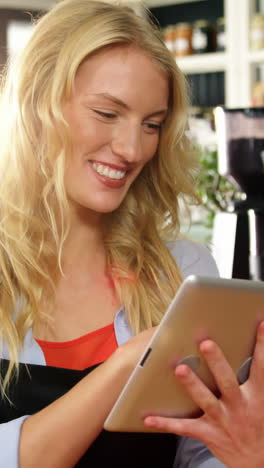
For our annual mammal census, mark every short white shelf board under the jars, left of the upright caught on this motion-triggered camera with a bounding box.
[176,52,227,74]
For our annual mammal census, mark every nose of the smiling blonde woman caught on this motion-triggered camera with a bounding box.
[111,122,143,163]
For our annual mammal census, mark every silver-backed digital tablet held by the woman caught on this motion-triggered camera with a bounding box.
[104,275,264,432]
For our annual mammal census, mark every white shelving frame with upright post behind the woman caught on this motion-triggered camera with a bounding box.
[143,0,264,107]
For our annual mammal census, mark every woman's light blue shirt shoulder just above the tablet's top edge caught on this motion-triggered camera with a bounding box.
[167,239,219,278]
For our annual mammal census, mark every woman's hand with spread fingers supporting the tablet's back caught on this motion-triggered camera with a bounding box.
[145,322,264,468]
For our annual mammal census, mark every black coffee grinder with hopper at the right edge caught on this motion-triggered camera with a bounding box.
[212,107,264,281]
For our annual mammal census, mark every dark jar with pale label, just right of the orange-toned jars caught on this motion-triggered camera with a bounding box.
[192,20,216,54]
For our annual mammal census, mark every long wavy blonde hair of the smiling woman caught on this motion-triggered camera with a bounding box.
[0,0,197,389]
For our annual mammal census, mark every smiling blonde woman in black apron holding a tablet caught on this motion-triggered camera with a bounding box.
[0,0,264,468]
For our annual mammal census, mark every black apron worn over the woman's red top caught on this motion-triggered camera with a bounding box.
[0,359,178,468]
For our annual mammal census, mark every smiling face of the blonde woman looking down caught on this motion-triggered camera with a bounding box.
[63,45,169,219]
